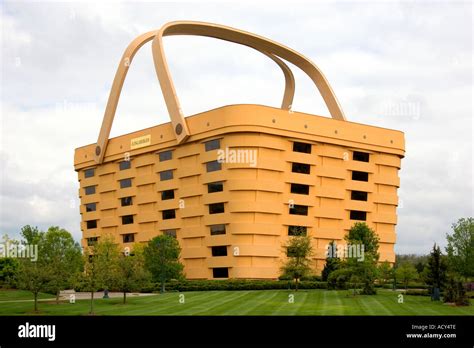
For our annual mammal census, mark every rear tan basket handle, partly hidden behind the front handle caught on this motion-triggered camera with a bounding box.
[94,30,295,164]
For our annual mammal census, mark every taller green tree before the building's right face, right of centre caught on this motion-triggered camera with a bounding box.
[344,222,379,295]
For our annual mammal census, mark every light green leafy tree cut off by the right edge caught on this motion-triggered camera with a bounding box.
[446,217,474,278]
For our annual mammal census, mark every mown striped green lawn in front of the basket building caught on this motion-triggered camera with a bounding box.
[0,290,474,315]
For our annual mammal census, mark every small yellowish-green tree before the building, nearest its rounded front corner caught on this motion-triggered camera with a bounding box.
[281,235,312,291]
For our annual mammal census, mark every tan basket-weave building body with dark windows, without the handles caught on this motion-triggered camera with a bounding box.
[74,105,405,279]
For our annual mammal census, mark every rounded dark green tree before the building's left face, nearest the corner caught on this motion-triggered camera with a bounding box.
[144,235,184,293]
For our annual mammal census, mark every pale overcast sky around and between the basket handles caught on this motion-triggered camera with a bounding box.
[0,1,473,253]
